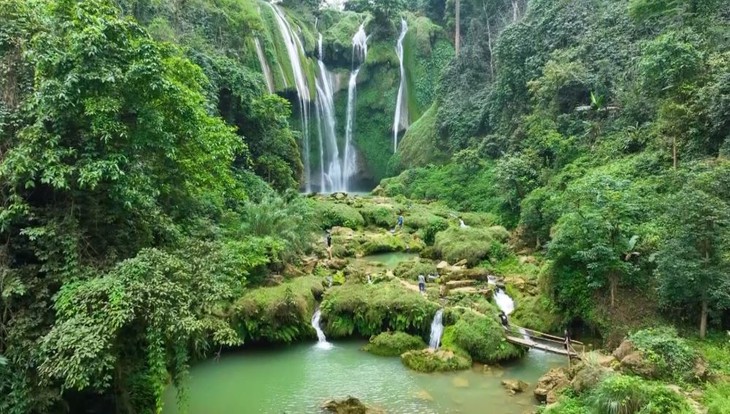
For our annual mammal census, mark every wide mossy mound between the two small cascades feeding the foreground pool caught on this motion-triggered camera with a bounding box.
[321,281,438,337]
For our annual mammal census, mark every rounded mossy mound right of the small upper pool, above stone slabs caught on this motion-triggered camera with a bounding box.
[434,226,509,266]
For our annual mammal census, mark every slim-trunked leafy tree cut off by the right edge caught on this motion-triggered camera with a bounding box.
[656,170,730,338]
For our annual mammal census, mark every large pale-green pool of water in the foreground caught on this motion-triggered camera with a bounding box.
[162,342,567,414]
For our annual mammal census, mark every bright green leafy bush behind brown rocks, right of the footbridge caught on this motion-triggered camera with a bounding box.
[629,327,698,380]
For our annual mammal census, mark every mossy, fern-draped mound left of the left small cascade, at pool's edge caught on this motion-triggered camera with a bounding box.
[228,276,323,343]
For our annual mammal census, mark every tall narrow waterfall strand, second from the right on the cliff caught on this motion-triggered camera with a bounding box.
[342,23,368,191]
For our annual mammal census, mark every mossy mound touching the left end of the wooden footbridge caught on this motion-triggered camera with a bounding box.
[442,310,525,364]
